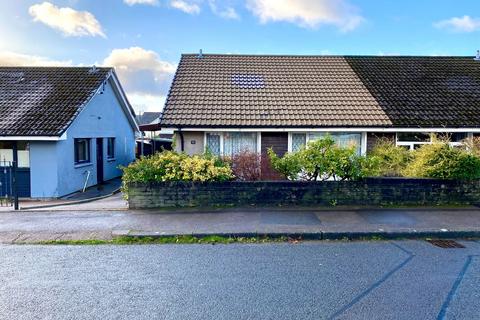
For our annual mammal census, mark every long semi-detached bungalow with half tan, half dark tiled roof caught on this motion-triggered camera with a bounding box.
[160,54,480,178]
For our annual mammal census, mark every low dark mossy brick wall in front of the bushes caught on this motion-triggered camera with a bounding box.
[128,178,480,209]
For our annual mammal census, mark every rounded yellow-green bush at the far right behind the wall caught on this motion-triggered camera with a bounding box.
[404,140,480,180]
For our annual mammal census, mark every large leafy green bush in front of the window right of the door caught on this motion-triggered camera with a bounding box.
[268,136,363,181]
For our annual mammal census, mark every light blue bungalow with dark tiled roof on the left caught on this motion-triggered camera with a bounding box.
[0,67,138,198]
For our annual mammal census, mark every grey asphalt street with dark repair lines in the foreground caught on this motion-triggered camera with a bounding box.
[0,241,480,319]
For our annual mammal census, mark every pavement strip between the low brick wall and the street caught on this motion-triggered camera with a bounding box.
[0,208,480,243]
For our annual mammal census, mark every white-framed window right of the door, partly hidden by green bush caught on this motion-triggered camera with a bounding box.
[288,132,367,154]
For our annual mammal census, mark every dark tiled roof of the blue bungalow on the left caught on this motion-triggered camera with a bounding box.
[0,67,112,136]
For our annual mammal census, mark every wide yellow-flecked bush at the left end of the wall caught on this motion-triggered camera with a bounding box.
[122,151,233,187]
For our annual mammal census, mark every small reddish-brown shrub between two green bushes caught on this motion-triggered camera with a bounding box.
[228,150,261,181]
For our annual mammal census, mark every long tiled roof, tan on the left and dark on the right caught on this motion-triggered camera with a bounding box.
[161,54,480,127]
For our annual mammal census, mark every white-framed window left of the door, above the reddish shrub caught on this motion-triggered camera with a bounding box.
[204,131,261,156]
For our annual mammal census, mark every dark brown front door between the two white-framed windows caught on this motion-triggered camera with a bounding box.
[261,132,288,180]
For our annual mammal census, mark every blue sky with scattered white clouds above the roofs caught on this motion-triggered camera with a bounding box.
[0,0,480,111]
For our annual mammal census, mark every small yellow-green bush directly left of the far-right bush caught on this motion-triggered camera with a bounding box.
[364,138,412,177]
